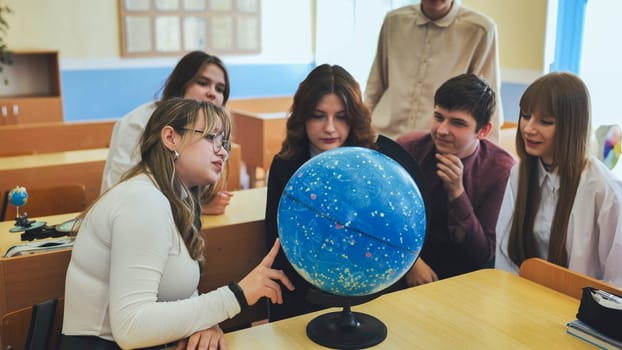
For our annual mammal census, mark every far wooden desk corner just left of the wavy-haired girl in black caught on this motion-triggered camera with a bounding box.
[231,109,288,185]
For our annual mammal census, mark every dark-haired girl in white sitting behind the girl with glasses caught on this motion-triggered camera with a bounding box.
[102,51,233,215]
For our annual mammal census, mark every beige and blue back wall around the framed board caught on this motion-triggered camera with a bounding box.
[0,0,314,121]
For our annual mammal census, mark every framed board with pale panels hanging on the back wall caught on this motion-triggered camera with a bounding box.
[119,0,261,57]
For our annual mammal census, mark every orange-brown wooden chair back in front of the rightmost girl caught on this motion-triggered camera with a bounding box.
[518,258,622,299]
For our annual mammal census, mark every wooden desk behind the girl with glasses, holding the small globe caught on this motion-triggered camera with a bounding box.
[0,188,266,329]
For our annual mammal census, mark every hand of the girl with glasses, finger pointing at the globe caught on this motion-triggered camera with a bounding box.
[239,239,294,305]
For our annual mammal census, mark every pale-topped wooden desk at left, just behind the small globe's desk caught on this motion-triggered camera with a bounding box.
[0,148,108,205]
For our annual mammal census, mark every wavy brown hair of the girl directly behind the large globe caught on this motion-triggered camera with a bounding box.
[279,64,375,159]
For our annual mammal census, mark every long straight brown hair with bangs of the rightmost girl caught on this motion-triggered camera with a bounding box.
[508,73,591,266]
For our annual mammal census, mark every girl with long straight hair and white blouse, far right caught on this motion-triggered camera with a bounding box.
[495,73,622,287]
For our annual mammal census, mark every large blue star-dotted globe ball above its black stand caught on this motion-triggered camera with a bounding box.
[277,147,426,296]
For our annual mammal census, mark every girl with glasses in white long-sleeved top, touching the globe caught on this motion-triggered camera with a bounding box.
[61,98,293,349]
